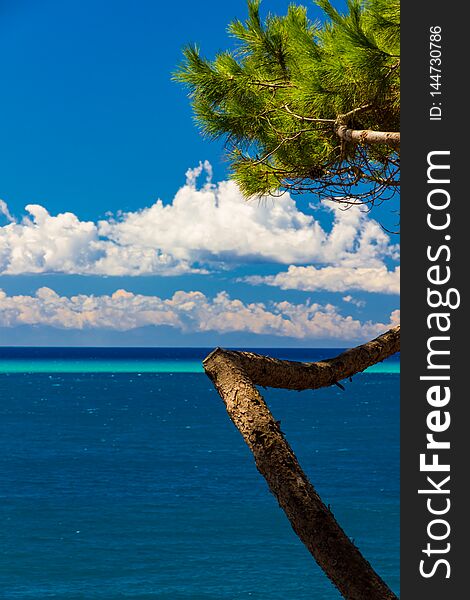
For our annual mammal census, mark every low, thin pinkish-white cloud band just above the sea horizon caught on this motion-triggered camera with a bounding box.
[0,287,399,341]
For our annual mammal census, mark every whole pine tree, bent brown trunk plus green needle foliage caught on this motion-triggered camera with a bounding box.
[175,0,400,600]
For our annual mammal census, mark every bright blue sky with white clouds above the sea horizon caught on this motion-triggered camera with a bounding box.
[0,0,399,347]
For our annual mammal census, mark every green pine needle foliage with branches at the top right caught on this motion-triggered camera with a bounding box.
[175,0,400,204]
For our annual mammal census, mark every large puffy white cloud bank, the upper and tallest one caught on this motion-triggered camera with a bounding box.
[0,162,397,285]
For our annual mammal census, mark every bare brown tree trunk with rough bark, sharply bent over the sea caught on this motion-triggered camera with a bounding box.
[204,327,400,600]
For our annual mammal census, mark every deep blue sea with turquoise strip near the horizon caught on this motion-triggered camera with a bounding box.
[0,348,399,600]
